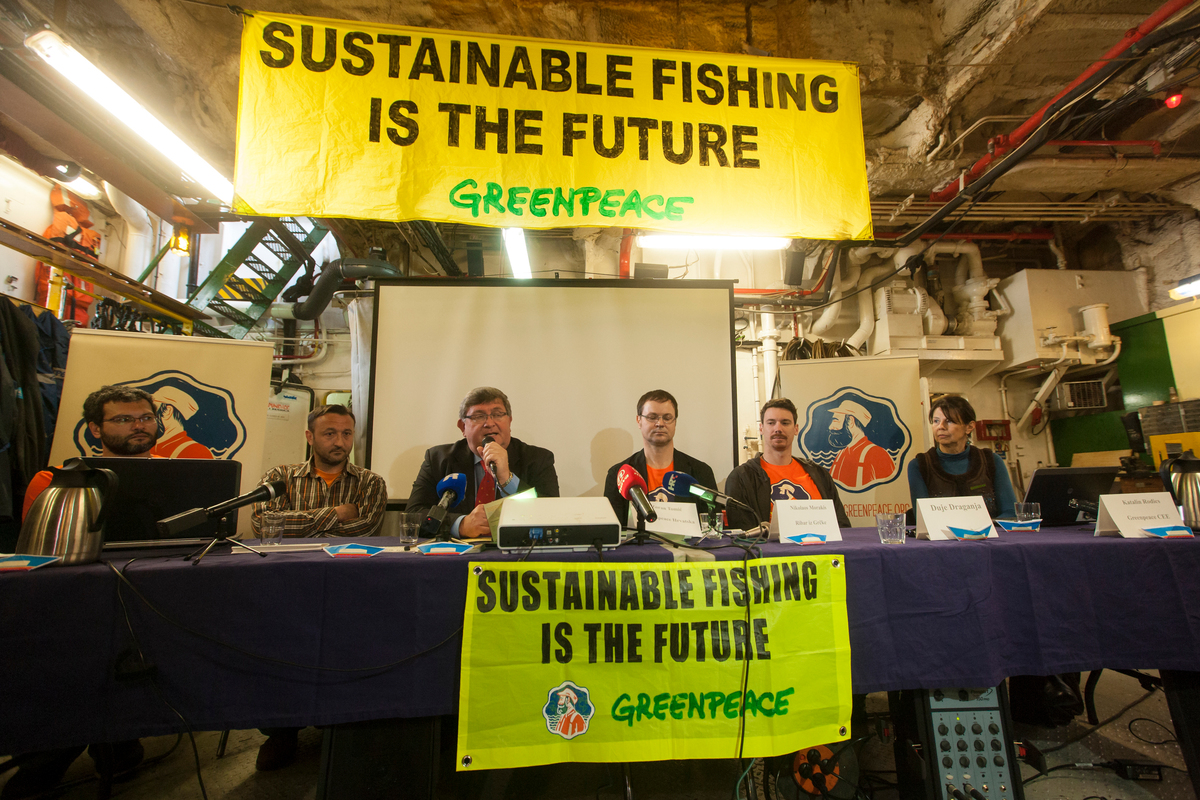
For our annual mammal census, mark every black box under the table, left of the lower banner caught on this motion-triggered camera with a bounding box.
[317,717,442,800]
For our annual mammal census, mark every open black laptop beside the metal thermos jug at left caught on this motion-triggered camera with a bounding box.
[84,458,241,549]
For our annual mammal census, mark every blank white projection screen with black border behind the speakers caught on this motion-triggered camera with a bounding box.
[366,278,737,500]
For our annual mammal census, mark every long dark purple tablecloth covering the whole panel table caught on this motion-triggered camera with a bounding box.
[0,529,1200,752]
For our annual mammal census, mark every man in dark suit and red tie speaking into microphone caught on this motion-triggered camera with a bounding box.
[407,386,558,539]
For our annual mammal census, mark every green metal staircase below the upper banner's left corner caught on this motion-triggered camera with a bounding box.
[187,217,329,339]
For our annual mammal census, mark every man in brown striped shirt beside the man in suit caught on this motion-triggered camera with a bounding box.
[251,405,388,536]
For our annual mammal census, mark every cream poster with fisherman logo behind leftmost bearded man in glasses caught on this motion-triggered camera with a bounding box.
[50,329,275,533]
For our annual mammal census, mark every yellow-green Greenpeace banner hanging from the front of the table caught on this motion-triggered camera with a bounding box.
[457,555,851,770]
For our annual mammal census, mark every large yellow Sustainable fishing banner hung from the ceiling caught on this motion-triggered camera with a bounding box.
[234,12,872,239]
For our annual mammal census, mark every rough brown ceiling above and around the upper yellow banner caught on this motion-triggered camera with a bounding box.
[7,0,1200,237]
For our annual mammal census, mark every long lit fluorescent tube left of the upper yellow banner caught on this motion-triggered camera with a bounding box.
[25,30,233,205]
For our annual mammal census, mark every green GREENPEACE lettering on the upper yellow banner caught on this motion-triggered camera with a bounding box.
[449,178,696,222]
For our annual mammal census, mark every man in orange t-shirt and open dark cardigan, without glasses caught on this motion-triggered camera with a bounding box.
[725,397,850,530]
